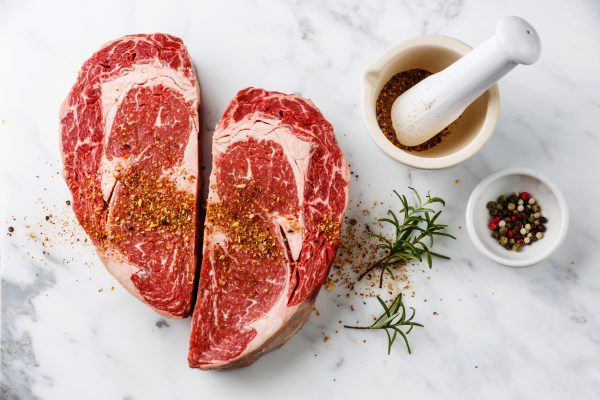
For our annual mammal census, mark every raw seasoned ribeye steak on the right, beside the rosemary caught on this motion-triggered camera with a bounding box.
[188,88,349,369]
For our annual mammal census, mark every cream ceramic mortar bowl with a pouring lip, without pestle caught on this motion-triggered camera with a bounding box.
[362,35,500,169]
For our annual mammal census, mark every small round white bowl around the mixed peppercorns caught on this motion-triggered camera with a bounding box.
[466,168,569,267]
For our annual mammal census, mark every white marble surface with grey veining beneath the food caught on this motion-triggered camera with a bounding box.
[0,0,600,400]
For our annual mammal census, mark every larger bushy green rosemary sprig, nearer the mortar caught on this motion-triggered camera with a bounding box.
[358,187,456,288]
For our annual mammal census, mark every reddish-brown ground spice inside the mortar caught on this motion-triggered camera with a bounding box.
[375,68,450,151]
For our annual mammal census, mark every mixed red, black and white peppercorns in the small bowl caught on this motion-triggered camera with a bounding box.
[487,192,548,251]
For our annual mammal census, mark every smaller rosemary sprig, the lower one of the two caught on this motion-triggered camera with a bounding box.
[344,293,423,354]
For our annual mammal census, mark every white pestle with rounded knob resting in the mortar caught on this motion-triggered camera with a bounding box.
[392,16,542,146]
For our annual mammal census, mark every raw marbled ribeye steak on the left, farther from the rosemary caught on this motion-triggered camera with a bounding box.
[60,34,200,317]
